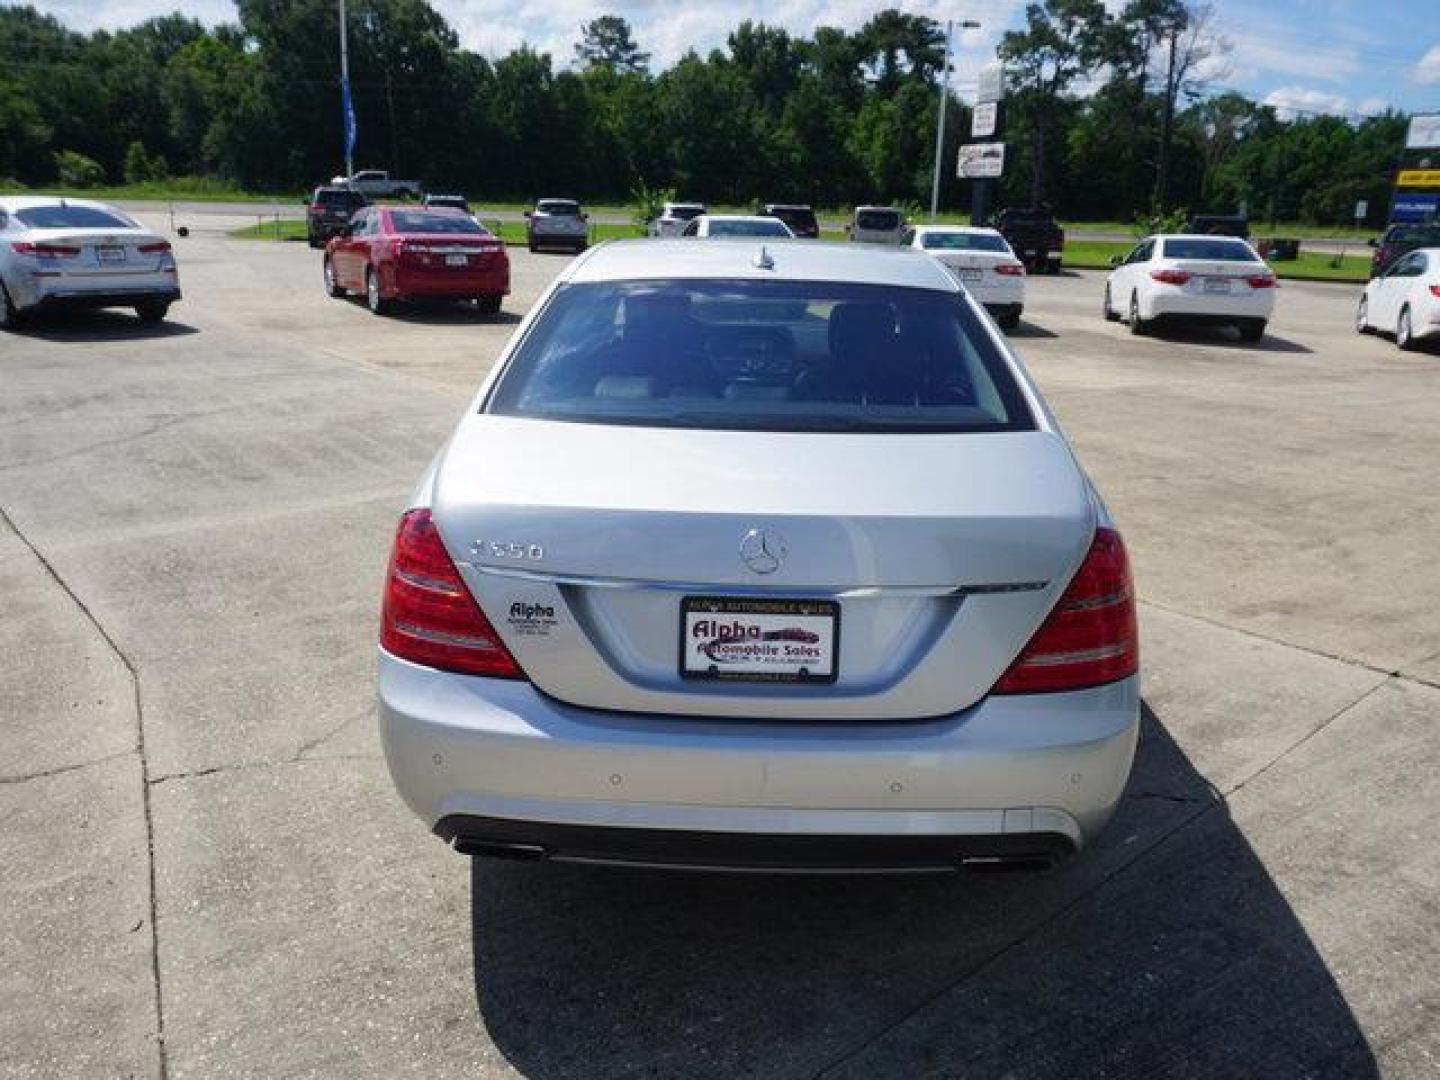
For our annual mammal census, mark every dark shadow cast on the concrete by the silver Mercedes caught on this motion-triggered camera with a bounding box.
[471,708,1378,1080]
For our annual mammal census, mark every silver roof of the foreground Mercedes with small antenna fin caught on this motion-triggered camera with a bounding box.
[560,236,960,292]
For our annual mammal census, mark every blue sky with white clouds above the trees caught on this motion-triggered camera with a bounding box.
[22,0,1440,114]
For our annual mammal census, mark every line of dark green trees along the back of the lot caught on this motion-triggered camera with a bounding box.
[0,0,1405,225]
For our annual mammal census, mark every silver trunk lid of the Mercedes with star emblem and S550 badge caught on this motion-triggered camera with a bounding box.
[432,415,1094,719]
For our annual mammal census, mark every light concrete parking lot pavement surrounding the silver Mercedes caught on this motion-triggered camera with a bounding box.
[0,215,1440,1080]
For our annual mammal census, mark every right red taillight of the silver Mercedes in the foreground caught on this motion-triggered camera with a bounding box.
[994,528,1140,694]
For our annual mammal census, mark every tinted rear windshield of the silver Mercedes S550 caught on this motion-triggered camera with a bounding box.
[485,279,1034,434]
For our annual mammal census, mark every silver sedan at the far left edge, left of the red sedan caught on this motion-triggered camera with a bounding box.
[0,196,180,330]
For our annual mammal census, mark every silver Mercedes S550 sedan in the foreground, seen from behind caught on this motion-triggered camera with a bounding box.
[379,240,1139,870]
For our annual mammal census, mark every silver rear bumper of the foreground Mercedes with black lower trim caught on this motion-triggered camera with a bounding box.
[379,652,1139,870]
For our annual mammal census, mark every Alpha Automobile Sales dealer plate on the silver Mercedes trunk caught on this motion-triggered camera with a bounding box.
[680,596,840,683]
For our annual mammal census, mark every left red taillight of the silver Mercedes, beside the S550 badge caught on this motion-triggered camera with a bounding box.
[380,510,526,678]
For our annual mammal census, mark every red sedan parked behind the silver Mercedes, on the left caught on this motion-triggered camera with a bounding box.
[325,206,510,315]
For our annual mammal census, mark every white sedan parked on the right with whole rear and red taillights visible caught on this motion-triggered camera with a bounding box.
[1103,235,1276,341]
